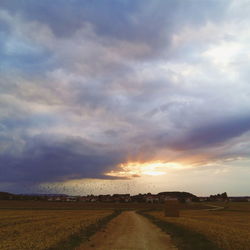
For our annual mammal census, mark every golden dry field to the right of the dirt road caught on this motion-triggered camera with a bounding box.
[148,203,250,250]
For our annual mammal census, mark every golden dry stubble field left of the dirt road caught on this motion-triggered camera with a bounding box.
[0,210,112,250]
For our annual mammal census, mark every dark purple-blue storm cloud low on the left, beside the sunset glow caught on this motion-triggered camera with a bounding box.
[0,136,123,183]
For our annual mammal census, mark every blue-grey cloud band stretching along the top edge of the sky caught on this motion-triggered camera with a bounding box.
[1,0,228,55]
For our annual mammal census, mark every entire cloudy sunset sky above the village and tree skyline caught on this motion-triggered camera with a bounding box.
[0,0,250,196]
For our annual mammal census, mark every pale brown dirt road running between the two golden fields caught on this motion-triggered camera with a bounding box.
[78,211,177,250]
